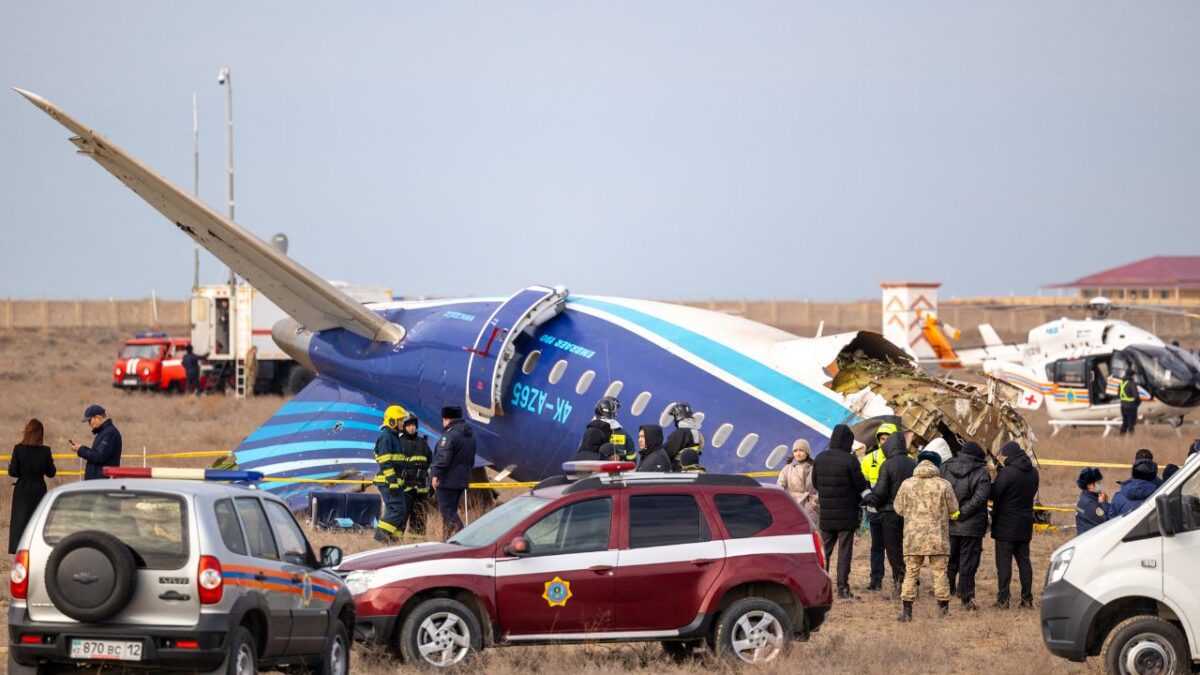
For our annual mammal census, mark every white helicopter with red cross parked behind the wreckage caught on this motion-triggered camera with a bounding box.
[955,297,1200,434]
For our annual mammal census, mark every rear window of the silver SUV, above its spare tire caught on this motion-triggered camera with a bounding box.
[42,490,188,569]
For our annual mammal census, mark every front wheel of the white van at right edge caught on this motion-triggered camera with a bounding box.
[1100,616,1192,675]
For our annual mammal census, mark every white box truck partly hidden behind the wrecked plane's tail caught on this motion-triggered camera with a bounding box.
[192,281,392,394]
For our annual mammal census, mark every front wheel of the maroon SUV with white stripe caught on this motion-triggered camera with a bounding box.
[400,598,484,668]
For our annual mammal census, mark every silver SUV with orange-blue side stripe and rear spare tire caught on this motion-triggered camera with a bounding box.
[8,478,354,675]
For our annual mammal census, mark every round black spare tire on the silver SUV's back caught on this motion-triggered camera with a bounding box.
[46,530,138,623]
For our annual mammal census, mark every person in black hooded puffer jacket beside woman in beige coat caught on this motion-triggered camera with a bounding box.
[812,424,869,599]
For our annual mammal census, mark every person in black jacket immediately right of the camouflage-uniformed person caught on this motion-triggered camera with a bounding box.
[942,442,991,611]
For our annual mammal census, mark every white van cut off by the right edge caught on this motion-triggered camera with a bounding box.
[1042,455,1200,675]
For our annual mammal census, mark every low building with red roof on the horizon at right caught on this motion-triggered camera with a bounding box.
[1049,256,1200,303]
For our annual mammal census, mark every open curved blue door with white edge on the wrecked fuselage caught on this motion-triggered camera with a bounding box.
[467,286,568,424]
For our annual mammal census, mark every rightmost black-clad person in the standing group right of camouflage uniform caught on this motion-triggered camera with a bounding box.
[991,441,1038,609]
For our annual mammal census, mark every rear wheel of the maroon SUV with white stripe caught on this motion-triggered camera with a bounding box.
[713,598,792,663]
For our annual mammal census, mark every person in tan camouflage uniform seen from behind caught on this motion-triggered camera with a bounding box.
[893,453,959,621]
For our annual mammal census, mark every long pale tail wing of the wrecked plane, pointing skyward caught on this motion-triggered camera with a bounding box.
[16,89,404,342]
